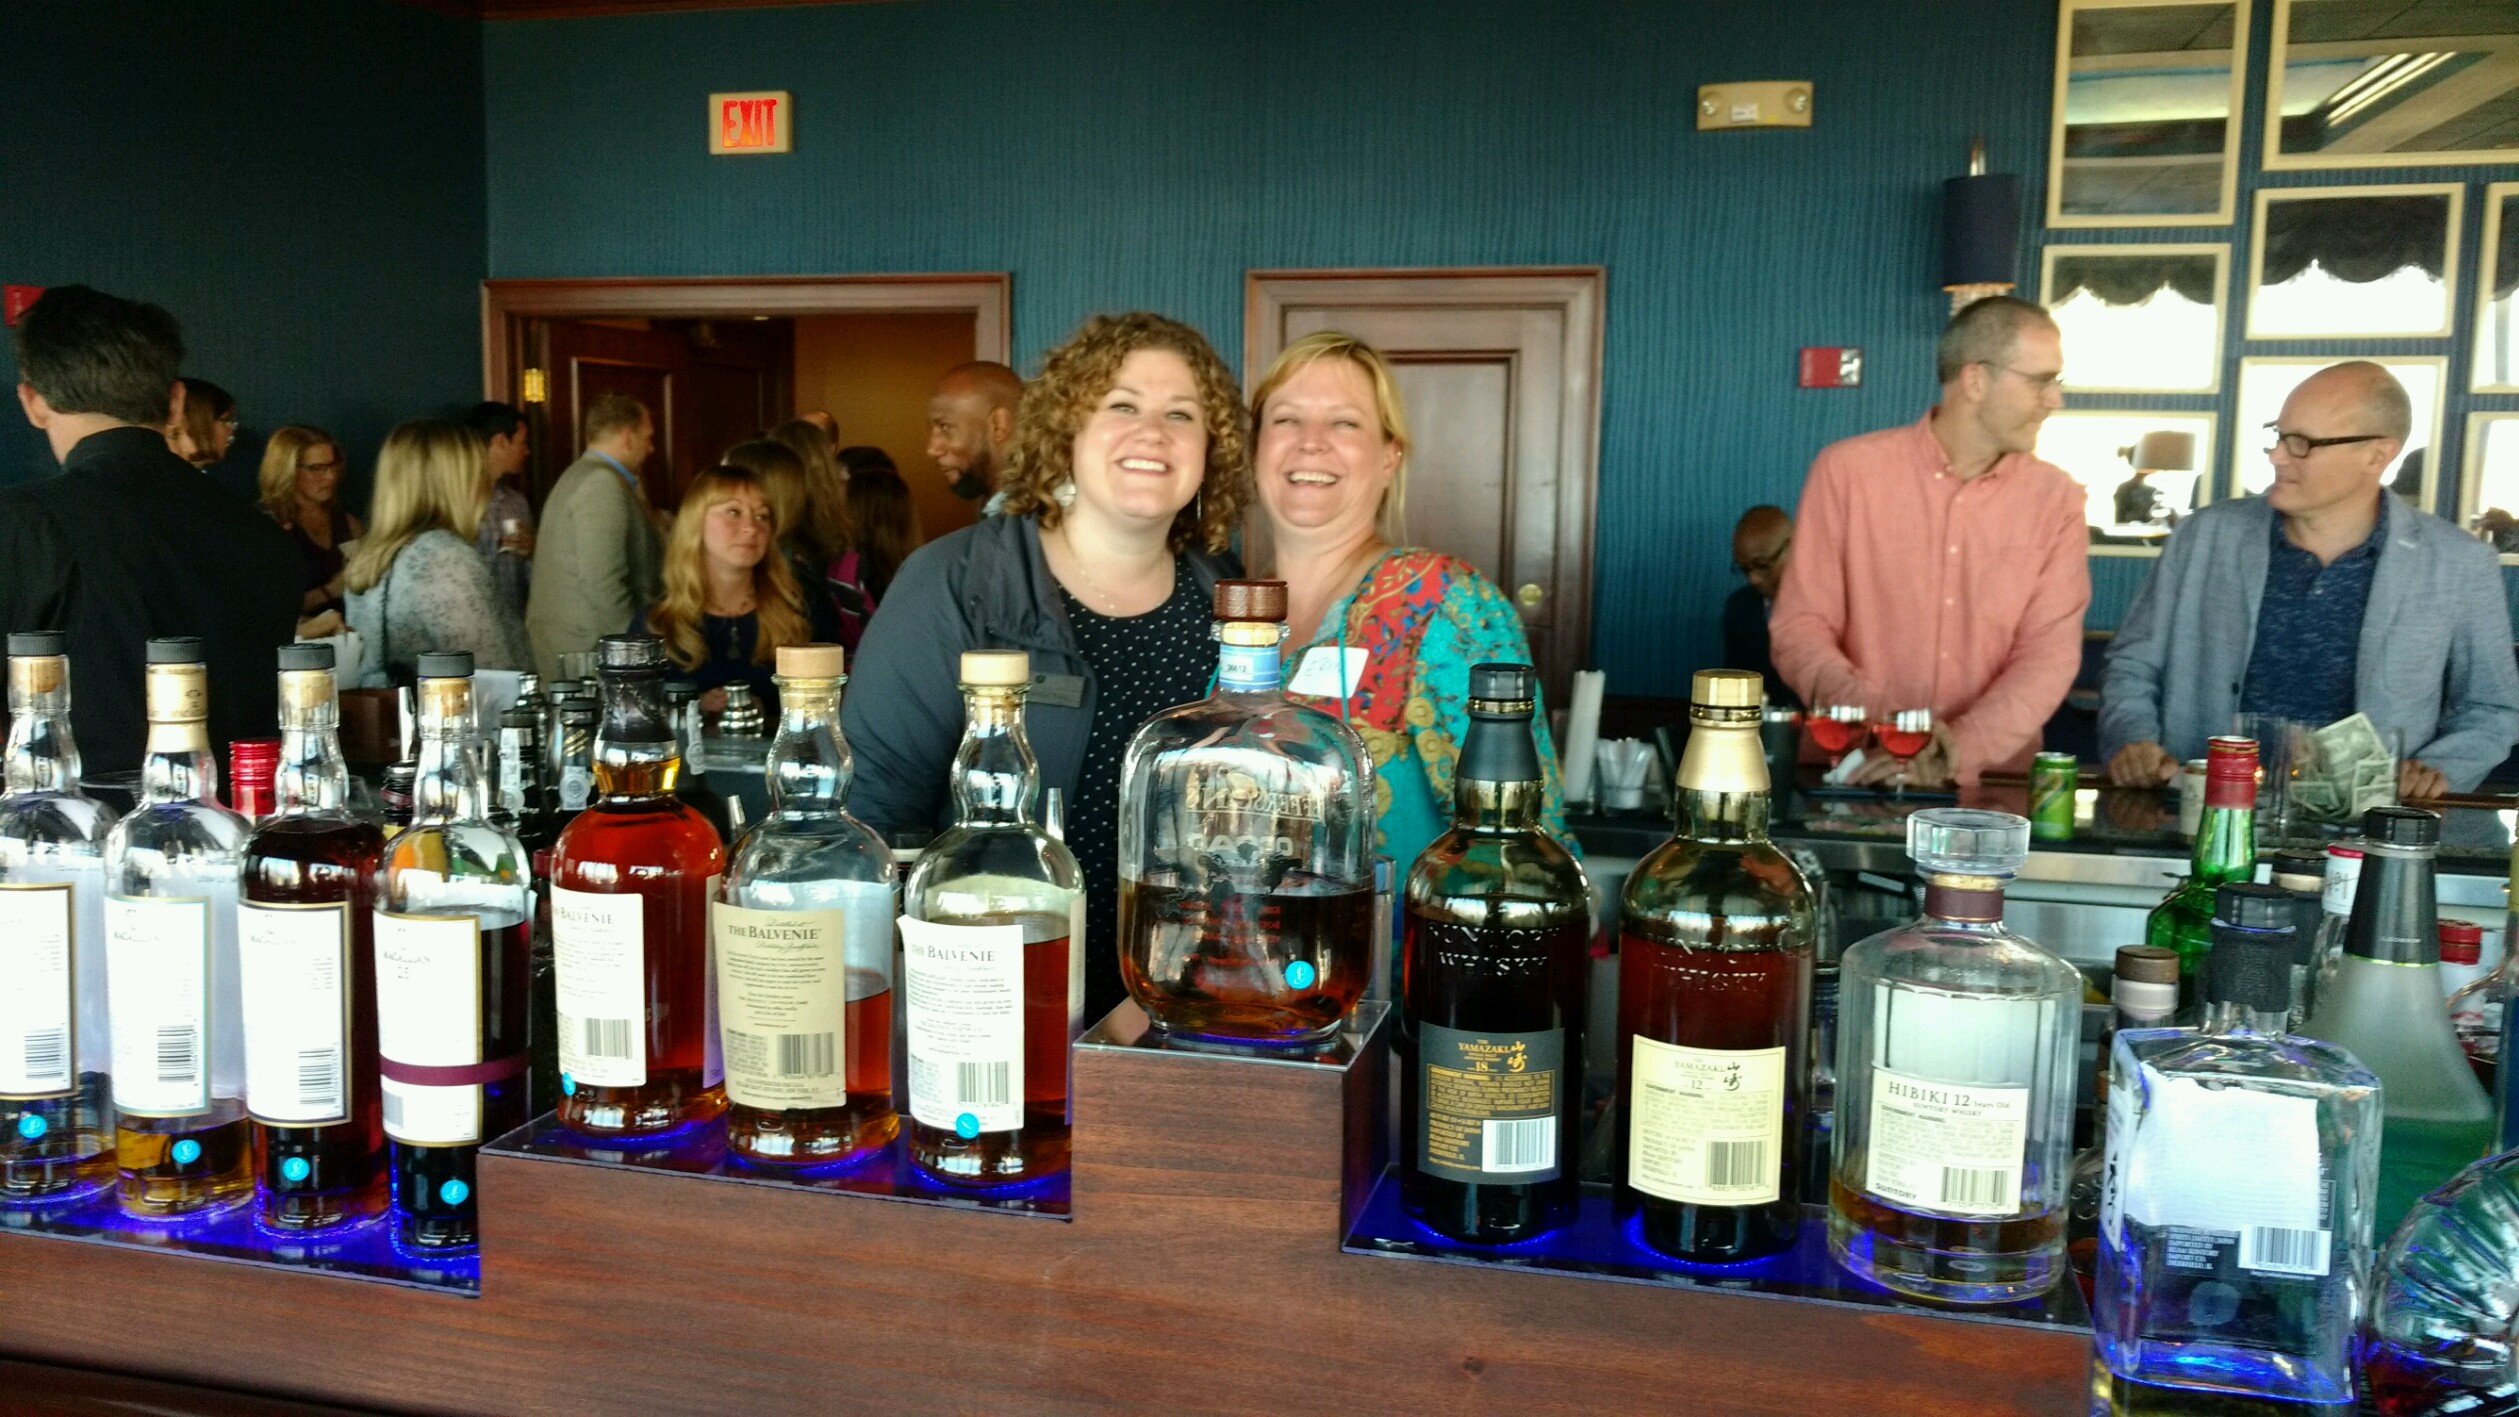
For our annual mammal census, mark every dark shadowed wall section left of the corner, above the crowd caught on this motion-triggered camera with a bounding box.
[0,0,484,503]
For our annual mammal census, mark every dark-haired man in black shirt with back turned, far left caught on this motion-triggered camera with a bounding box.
[0,284,300,775]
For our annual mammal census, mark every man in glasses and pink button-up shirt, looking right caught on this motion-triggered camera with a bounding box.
[1768,294,2091,785]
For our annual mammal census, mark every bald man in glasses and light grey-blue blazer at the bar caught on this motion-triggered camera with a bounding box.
[2098,360,2519,800]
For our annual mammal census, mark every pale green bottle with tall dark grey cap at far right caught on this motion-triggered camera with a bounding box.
[2302,808,2494,1226]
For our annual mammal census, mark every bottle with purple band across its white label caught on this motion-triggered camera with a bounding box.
[375,652,532,1251]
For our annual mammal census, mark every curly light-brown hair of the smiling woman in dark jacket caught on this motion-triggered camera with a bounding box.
[1003,312,1252,551]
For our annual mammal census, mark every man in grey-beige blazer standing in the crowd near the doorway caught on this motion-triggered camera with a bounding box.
[524,393,665,682]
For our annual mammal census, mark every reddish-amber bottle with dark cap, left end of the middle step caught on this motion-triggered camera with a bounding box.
[552,634,725,1138]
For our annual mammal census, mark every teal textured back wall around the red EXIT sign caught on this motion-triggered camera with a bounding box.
[484,0,2056,695]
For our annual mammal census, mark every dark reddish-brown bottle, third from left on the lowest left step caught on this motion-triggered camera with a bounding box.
[237,644,385,1231]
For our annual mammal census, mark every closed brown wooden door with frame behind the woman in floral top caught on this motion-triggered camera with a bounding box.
[1242,267,1602,705]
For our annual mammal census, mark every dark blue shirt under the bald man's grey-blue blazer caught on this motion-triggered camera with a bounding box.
[2239,493,2396,725]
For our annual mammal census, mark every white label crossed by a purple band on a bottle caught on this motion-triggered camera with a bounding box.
[375,911,481,1145]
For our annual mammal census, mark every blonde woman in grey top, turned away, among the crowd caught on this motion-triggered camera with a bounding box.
[343,418,534,687]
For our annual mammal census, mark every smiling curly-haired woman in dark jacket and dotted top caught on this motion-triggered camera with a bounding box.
[841,315,1252,1022]
